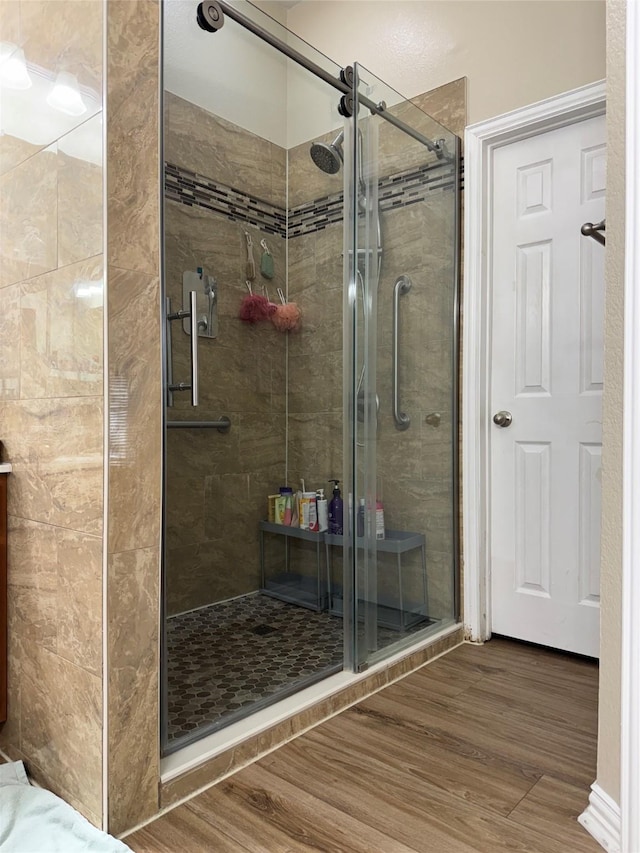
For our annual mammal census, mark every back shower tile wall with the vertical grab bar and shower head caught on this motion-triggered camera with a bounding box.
[288,80,465,618]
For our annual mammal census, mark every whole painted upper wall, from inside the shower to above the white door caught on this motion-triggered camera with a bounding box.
[164,0,605,147]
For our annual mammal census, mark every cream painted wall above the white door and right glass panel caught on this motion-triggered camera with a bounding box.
[287,0,605,123]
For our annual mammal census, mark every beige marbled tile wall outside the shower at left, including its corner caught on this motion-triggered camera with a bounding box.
[0,0,162,831]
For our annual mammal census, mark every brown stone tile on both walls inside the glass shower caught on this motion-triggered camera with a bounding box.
[165,81,465,617]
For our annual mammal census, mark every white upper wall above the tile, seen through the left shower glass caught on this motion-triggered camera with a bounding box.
[164,0,342,148]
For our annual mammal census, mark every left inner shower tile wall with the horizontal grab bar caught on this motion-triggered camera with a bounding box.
[165,92,286,614]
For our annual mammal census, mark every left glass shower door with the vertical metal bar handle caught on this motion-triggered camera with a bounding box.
[162,0,352,755]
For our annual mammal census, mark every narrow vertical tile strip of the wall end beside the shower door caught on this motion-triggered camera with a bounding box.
[106,0,162,833]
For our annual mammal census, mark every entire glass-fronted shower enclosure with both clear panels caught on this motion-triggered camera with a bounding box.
[162,0,460,754]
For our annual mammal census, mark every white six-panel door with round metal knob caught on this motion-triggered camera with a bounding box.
[490,117,606,657]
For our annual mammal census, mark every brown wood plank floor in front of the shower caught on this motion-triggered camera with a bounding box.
[125,639,601,853]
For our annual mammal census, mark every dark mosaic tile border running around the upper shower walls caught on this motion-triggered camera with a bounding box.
[165,158,455,238]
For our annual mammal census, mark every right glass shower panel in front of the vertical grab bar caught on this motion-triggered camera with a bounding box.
[345,65,459,669]
